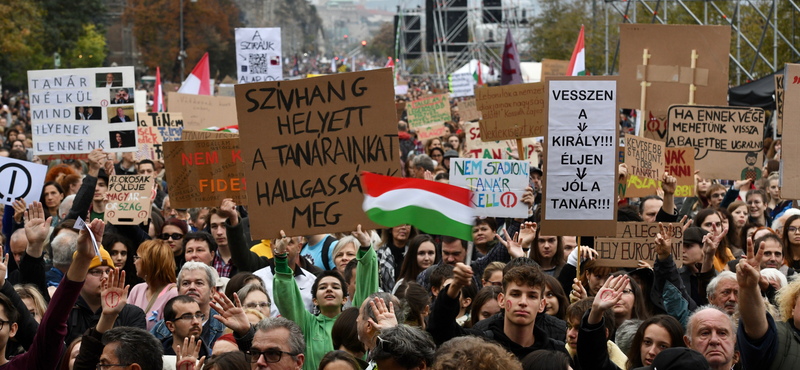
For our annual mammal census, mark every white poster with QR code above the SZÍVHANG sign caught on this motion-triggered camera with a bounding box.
[236,28,283,84]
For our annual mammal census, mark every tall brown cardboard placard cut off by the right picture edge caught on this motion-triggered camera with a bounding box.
[780,63,800,199]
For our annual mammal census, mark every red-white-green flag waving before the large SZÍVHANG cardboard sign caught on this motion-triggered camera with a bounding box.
[361,172,475,240]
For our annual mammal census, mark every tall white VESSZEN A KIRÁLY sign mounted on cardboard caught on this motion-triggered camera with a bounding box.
[541,76,627,236]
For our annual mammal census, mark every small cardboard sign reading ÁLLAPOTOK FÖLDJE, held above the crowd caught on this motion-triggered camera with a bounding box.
[104,175,155,225]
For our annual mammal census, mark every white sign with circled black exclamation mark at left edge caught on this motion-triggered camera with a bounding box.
[0,157,47,205]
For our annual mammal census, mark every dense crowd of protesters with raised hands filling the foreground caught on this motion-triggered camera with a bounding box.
[0,86,800,370]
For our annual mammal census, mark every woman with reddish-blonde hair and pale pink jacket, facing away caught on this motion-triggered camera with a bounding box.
[128,240,178,330]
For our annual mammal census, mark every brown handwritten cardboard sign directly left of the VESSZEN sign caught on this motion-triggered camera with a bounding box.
[475,82,545,141]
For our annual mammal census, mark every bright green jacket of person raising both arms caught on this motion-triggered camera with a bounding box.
[273,247,378,370]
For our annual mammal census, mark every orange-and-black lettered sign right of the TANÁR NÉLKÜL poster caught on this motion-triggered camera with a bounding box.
[134,112,183,161]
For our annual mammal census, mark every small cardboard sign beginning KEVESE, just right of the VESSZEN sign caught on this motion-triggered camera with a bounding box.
[625,135,665,198]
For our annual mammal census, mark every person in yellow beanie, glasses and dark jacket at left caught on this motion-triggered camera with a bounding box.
[62,247,147,343]
